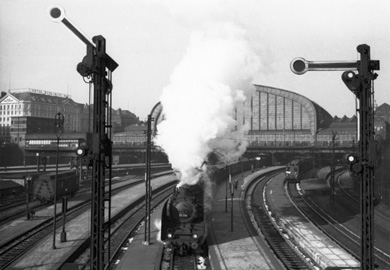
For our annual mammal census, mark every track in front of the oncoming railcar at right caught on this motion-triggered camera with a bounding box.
[288,178,390,269]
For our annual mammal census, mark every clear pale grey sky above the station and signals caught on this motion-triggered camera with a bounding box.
[0,0,390,119]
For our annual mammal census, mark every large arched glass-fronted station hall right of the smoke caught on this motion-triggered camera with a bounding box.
[236,85,390,147]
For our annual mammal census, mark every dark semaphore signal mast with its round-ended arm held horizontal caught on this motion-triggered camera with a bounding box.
[290,44,379,270]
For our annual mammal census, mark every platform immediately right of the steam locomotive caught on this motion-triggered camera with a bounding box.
[208,170,283,270]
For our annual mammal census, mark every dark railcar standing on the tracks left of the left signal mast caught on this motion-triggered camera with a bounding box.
[33,171,79,202]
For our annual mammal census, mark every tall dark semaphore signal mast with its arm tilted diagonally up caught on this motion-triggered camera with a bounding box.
[50,7,118,270]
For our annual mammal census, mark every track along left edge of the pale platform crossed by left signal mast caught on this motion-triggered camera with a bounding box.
[0,175,172,269]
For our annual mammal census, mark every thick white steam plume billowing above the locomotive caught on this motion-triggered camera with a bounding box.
[155,22,260,184]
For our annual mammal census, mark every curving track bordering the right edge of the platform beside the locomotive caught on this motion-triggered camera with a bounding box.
[247,172,311,269]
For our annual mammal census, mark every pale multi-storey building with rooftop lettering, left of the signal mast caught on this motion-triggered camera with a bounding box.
[0,88,84,144]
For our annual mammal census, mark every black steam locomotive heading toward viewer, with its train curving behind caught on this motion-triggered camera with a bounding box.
[161,160,254,255]
